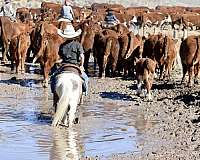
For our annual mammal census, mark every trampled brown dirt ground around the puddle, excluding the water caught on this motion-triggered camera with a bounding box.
[0,60,200,160]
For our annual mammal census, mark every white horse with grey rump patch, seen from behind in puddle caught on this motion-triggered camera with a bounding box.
[52,71,83,127]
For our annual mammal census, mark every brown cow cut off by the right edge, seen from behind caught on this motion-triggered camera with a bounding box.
[180,36,200,87]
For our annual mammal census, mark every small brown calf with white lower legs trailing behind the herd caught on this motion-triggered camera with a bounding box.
[135,58,156,100]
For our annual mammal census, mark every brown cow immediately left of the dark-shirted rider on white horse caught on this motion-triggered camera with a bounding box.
[33,33,64,87]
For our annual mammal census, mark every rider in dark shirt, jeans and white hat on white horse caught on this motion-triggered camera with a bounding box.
[52,23,89,95]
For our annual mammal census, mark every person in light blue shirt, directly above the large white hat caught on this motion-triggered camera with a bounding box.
[59,0,74,21]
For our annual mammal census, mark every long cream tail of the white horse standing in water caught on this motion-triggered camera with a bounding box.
[52,84,69,127]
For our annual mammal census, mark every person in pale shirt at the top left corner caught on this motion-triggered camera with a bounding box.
[0,0,16,21]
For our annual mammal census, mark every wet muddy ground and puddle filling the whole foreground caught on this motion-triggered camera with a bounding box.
[0,63,200,160]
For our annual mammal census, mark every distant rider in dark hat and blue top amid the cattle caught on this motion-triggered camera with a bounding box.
[104,8,120,28]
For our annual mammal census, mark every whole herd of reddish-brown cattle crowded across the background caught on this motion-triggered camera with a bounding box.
[0,2,200,100]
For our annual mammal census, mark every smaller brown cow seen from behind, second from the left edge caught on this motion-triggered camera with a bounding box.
[10,33,31,73]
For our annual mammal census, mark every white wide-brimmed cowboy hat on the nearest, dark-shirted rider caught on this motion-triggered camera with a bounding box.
[57,24,82,38]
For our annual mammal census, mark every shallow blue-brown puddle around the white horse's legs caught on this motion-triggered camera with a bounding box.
[0,77,158,160]
